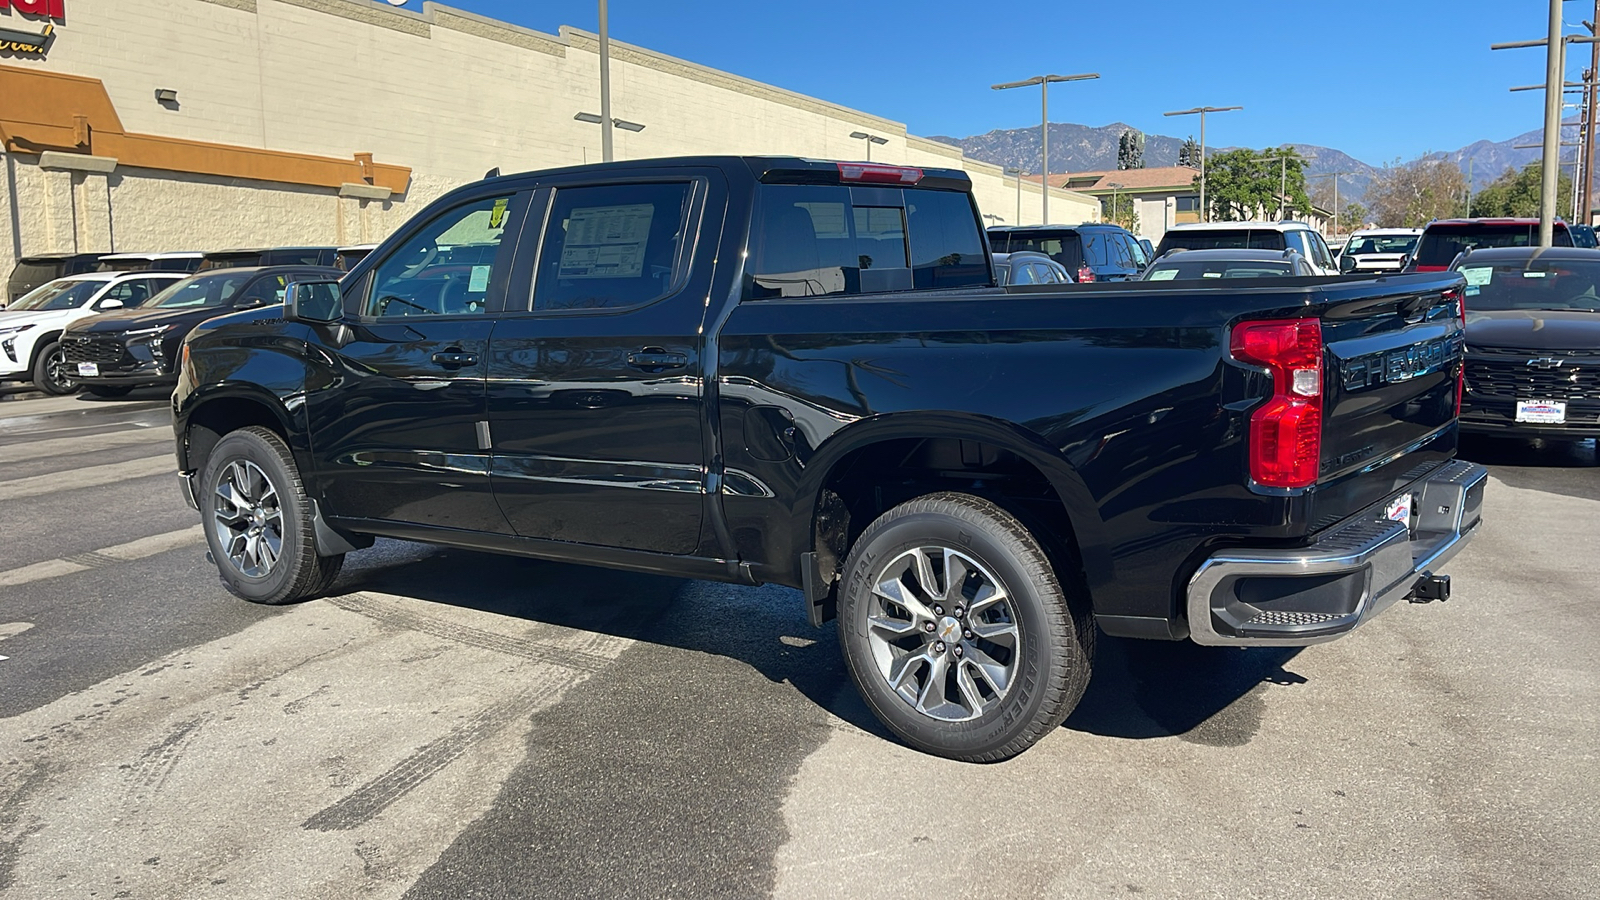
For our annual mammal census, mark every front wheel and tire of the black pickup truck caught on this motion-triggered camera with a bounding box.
[198,426,344,605]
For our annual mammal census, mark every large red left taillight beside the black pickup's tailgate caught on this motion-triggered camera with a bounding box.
[1232,319,1322,487]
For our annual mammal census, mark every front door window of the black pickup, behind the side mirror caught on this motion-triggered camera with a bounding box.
[363,195,512,319]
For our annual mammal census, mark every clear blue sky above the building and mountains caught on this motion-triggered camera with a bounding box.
[396,0,1594,165]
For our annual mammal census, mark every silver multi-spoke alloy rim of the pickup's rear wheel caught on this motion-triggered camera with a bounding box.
[867,546,1022,722]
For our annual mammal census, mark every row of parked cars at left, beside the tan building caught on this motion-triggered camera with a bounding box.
[0,247,371,397]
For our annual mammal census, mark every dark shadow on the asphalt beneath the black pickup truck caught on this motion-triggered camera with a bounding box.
[338,541,1306,746]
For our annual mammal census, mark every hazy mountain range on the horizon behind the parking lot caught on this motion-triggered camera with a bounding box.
[933,122,1578,205]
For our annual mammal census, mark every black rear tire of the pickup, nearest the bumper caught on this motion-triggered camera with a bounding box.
[838,493,1094,762]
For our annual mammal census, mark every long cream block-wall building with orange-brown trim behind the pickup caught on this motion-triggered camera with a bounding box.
[0,0,1099,274]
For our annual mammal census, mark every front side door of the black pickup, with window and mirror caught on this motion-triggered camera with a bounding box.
[307,185,531,533]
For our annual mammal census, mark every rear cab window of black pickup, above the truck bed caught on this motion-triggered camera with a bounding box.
[744,184,990,299]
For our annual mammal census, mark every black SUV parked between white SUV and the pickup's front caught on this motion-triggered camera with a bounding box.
[61,266,342,397]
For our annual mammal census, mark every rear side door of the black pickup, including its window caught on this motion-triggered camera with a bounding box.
[488,167,726,554]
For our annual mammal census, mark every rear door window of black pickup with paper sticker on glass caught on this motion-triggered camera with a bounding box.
[533,181,693,311]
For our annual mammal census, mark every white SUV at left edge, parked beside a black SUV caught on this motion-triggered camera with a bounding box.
[0,272,189,394]
